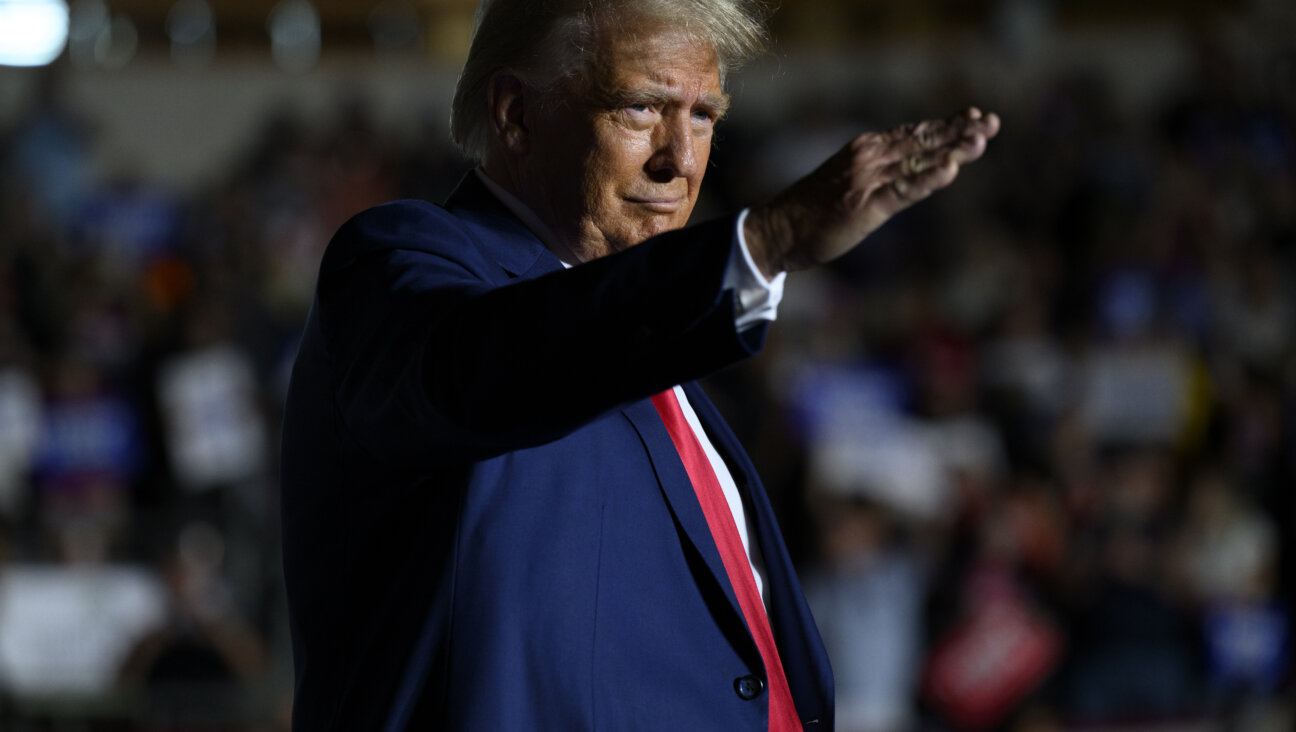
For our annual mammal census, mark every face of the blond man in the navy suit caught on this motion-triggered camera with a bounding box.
[521,23,728,262]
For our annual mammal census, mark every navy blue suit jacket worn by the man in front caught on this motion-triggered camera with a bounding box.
[283,175,832,732]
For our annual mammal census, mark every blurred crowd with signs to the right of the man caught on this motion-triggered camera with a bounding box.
[714,25,1296,731]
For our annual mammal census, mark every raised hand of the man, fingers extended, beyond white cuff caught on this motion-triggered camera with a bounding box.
[743,108,999,277]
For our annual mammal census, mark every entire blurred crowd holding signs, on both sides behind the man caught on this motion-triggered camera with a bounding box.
[0,11,1296,732]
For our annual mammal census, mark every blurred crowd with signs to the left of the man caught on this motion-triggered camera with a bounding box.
[0,70,467,729]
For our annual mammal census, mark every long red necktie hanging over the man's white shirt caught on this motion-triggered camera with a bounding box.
[652,389,802,732]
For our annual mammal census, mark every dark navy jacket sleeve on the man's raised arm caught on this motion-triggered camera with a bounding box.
[308,196,765,468]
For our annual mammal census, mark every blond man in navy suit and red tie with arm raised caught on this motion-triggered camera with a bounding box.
[283,0,998,732]
